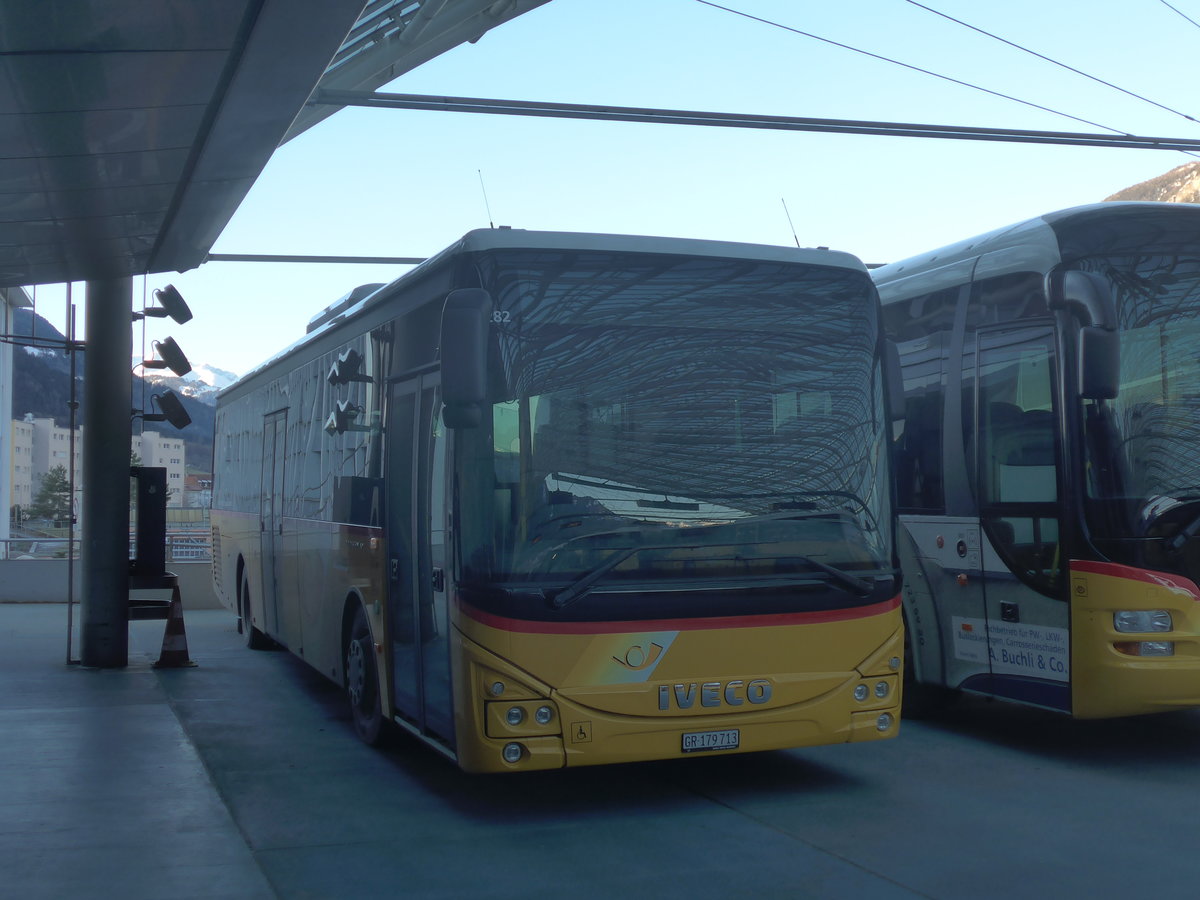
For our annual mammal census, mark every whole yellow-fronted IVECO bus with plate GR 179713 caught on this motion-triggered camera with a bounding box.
[212,229,902,772]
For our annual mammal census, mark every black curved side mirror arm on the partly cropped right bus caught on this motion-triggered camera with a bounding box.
[1050,271,1121,400]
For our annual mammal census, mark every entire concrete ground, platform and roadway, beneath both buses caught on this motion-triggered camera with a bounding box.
[11,599,1200,900]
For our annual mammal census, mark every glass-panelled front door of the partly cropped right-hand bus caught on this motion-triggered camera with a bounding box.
[974,324,1070,710]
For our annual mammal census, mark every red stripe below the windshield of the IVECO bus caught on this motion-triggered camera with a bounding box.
[458,594,900,635]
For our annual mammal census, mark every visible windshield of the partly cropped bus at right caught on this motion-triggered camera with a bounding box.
[1080,253,1200,554]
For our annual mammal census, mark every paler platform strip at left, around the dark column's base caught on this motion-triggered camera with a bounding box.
[0,602,275,900]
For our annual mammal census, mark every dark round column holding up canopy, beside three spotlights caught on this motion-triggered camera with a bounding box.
[79,277,133,668]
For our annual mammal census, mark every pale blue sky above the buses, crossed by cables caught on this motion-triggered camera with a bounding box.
[25,0,1200,373]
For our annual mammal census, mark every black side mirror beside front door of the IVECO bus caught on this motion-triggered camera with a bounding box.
[440,288,492,428]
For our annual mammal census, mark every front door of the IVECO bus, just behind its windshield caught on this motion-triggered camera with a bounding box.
[385,374,454,746]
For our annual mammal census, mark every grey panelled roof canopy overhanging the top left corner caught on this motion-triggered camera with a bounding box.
[0,0,546,287]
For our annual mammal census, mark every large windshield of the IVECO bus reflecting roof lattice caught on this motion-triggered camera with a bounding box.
[458,251,893,596]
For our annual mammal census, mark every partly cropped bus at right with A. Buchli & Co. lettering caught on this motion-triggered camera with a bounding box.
[872,203,1200,718]
